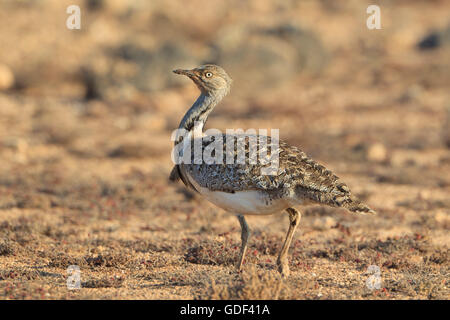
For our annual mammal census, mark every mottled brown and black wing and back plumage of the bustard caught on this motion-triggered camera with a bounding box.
[171,134,373,213]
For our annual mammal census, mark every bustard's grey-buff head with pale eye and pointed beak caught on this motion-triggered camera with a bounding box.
[173,64,232,95]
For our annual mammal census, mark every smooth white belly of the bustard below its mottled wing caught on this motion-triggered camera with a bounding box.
[188,174,290,215]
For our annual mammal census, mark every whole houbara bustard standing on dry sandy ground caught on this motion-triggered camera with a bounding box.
[170,64,375,276]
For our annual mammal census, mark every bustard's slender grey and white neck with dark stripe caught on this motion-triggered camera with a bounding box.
[178,90,227,133]
